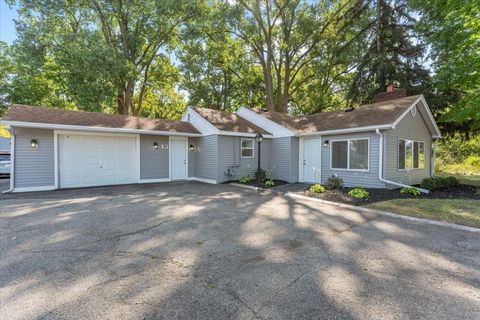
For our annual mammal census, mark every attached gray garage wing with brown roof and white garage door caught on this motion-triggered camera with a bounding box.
[1,105,202,192]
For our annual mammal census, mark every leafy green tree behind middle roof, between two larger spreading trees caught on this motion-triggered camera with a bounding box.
[176,4,264,111]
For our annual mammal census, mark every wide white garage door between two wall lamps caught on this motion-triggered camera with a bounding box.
[58,134,138,188]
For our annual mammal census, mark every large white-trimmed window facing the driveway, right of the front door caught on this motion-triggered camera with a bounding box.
[330,139,369,171]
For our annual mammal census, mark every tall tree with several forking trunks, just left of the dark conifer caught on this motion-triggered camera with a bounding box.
[223,0,362,112]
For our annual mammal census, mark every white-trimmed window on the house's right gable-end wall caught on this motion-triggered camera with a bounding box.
[398,139,425,170]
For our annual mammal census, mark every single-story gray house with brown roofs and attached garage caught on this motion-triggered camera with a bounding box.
[1,90,441,192]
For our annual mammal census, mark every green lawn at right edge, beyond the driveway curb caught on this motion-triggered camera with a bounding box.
[367,175,480,228]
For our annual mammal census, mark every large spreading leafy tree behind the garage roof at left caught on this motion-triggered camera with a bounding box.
[6,0,196,115]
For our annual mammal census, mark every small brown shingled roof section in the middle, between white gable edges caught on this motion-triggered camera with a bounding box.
[189,107,270,134]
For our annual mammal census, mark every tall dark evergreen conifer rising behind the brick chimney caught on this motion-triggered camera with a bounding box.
[348,0,430,104]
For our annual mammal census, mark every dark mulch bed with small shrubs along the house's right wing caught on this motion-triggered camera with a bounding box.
[298,184,480,206]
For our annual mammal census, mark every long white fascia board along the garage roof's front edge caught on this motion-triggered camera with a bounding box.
[0,121,202,137]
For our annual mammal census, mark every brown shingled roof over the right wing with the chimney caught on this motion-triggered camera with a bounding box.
[252,95,430,134]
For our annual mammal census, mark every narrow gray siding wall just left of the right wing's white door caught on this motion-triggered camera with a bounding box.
[271,137,298,182]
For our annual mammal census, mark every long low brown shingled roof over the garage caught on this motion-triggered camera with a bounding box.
[3,104,199,134]
